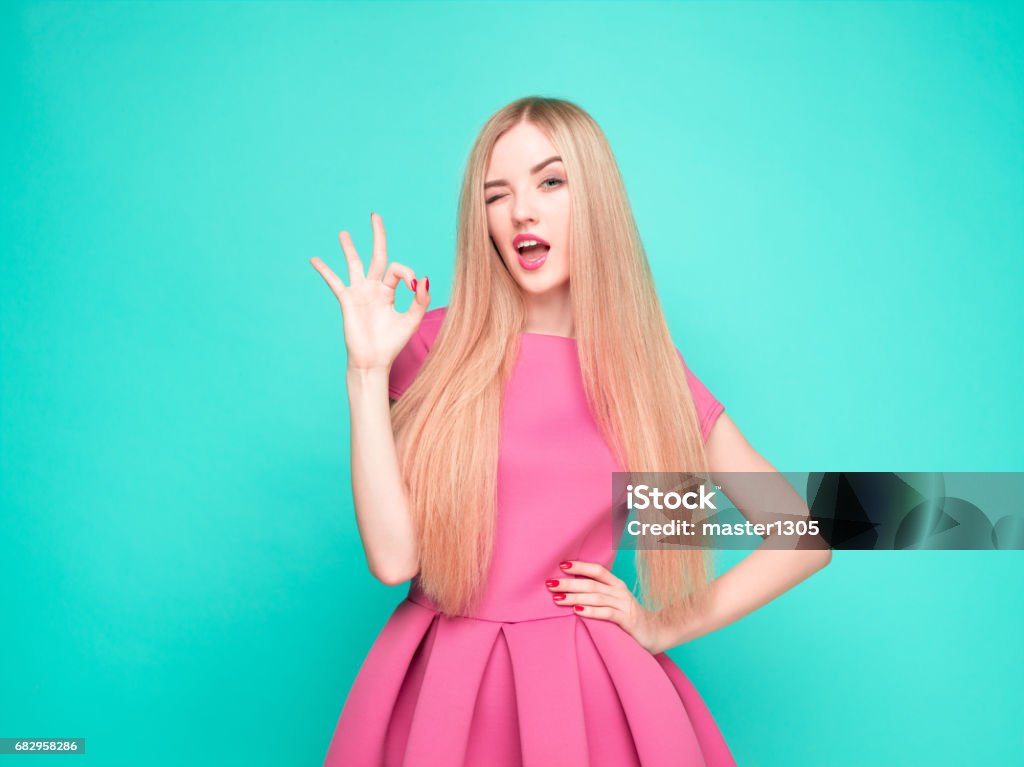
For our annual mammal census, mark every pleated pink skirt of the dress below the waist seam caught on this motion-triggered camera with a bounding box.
[325,599,735,767]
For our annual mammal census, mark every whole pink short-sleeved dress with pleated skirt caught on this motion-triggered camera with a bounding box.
[325,307,735,767]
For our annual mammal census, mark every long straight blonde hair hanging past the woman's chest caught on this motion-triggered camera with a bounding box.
[392,96,710,622]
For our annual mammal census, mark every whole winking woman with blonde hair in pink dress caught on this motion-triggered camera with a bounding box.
[312,97,829,767]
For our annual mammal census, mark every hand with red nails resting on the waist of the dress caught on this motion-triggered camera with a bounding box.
[545,560,670,654]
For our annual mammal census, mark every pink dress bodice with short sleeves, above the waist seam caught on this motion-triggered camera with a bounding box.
[391,307,722,622]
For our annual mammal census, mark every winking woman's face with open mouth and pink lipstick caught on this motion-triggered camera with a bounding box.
[483,123,570,294]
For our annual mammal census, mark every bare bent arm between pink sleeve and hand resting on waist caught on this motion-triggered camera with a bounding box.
[667,413,831,647]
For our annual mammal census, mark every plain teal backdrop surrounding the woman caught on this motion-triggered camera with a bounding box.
[0,2,1024,767]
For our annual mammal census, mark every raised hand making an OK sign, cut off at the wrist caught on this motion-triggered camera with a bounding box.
[309,213,430,370]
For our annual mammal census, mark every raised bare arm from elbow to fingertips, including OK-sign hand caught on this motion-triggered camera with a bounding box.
[310,215,430,586]
